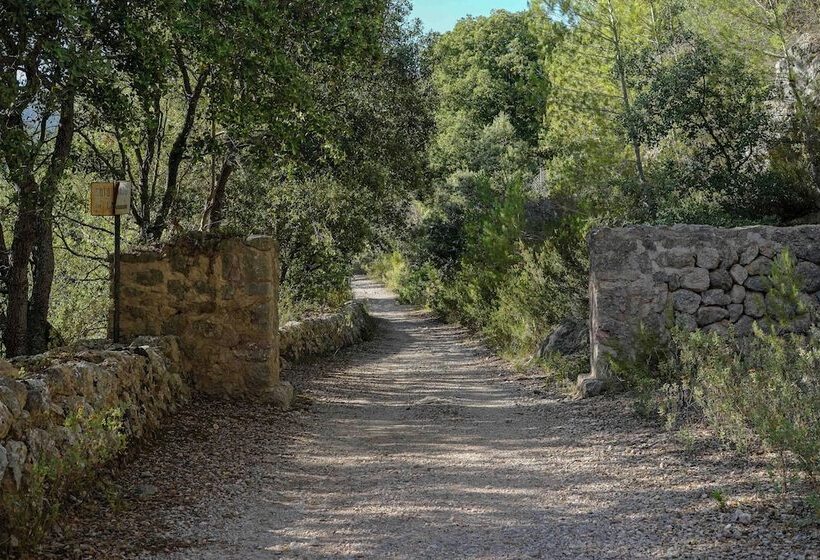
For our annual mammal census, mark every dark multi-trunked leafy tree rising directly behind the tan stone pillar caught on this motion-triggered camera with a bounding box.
[83,0,384,240]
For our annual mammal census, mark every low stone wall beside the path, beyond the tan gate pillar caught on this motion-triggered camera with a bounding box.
[279,301,373,362]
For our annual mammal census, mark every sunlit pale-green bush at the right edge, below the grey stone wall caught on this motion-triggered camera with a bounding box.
[679,328,820,490]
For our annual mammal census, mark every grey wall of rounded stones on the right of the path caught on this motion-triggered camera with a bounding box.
[580,225,820,394]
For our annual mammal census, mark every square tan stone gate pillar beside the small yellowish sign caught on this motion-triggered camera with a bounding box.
[115,234,293,407]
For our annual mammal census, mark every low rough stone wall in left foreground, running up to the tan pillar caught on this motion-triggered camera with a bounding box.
[0,337,191,551]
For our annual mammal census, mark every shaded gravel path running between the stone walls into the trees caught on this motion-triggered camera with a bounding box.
[35,278,820,560]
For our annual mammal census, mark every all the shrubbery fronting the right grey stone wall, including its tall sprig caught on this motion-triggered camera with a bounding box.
[611,252,820,498]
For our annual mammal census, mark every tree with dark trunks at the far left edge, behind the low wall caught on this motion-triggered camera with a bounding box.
[0,0,106,356]
